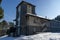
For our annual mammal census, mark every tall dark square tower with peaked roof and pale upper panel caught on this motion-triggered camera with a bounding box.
[15,1,36,35]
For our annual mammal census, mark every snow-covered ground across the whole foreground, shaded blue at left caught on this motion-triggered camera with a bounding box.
[0,33,60,40]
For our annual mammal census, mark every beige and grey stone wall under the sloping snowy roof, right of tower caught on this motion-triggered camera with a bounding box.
[27,16,48,34]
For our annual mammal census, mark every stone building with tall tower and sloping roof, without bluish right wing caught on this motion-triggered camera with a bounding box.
[15,1,50,35]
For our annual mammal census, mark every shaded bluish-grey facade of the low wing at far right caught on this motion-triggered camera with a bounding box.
[47,20,60,32]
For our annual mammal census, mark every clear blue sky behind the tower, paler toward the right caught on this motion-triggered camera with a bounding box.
[2,0,60,22]
